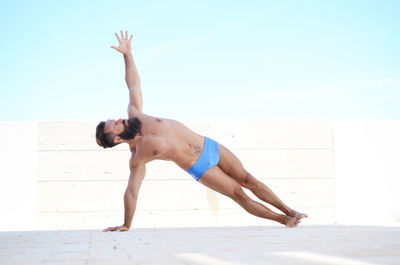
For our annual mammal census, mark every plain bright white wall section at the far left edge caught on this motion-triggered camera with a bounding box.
[0,122,36,231]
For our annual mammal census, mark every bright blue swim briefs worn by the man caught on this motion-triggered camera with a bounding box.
[186,137,219,181]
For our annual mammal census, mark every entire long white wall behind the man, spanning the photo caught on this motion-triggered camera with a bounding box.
[0,120,400,230]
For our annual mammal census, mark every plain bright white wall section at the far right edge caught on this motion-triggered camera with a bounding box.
[332,121,400,224]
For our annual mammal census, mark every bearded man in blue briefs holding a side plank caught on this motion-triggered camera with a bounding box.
[96,31,307,231]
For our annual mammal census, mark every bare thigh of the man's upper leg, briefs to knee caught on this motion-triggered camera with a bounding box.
[218,144,248,183]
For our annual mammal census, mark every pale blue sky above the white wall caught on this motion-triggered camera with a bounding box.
[0,1,400,121]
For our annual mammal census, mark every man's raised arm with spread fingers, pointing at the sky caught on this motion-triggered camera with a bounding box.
[111,30,143,114]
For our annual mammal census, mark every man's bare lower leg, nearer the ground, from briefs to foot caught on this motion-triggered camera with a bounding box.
[199,166,300,227]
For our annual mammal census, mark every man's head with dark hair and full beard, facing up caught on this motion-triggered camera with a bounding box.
[96,118,142,148]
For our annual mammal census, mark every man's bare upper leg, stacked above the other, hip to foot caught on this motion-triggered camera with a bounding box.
[218,144,307,219]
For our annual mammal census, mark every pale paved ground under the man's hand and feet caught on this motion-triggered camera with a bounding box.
[0,225,400,265]
